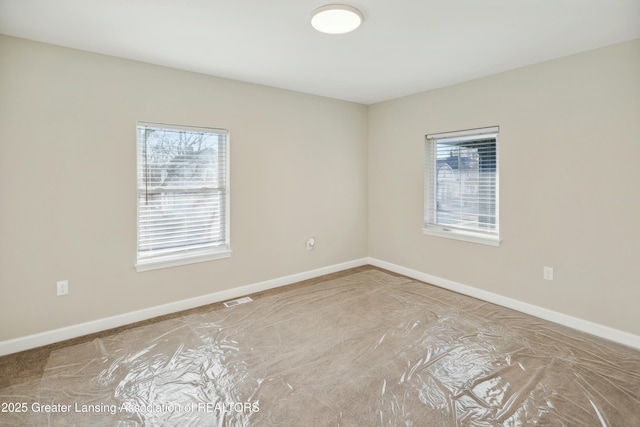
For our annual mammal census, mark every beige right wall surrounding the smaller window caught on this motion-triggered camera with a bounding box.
[369,40,640,334]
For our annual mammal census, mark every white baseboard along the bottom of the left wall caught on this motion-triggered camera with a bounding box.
[0,258,367,356]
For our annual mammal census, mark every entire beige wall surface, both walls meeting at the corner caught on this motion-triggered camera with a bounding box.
[0,36,640,341]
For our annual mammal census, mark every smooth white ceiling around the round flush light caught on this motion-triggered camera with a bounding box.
[0,0,640,104]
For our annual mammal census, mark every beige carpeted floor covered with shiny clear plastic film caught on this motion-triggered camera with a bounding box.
[0,269,640,427]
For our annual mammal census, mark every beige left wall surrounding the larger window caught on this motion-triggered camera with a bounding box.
[0,36,367,341]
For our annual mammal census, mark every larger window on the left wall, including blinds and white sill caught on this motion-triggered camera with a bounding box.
[136,123,231,271]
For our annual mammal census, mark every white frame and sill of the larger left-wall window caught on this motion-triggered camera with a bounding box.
[135,122,232,272]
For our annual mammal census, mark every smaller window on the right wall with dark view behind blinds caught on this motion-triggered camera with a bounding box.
[424,127,500,246]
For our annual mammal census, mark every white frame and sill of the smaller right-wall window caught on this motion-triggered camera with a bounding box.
[422,126,501,246]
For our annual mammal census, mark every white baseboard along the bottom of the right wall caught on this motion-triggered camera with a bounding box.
[368,258,640,349]
